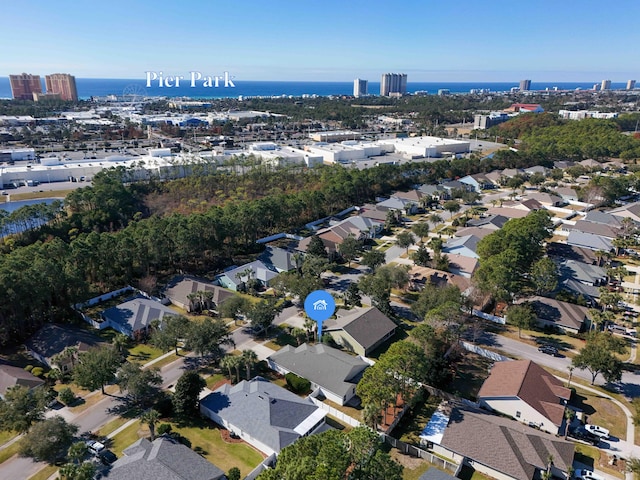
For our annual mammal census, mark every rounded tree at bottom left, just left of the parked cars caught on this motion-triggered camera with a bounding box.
[20,415,78,465]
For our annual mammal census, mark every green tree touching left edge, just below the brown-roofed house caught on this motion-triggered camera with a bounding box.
[0,385,50,433]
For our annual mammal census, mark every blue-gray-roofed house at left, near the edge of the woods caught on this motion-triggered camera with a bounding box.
[100,297,176,338]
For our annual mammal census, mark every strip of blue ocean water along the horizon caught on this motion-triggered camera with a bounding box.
[0,74,626,100]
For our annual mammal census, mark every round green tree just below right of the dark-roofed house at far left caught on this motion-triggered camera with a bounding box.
[73,345,122,394]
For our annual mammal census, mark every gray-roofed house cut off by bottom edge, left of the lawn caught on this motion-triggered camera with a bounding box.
[102,436,226,480]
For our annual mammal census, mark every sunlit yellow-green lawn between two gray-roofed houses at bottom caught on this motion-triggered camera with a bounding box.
[173,420,264,478]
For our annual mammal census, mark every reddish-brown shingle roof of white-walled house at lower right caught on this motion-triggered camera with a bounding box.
[478,360,571,427]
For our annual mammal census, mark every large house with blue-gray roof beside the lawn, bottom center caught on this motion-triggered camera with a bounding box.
[200,377,327,455]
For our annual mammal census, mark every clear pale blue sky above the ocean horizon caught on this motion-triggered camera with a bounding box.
[0,0,640,82]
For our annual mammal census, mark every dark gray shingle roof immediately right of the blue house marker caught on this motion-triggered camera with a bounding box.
[323,307,396,350]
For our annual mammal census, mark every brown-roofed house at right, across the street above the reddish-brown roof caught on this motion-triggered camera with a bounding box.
[507,296,589,333]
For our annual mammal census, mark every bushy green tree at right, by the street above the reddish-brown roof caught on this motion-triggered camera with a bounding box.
[571,332,626,385]
